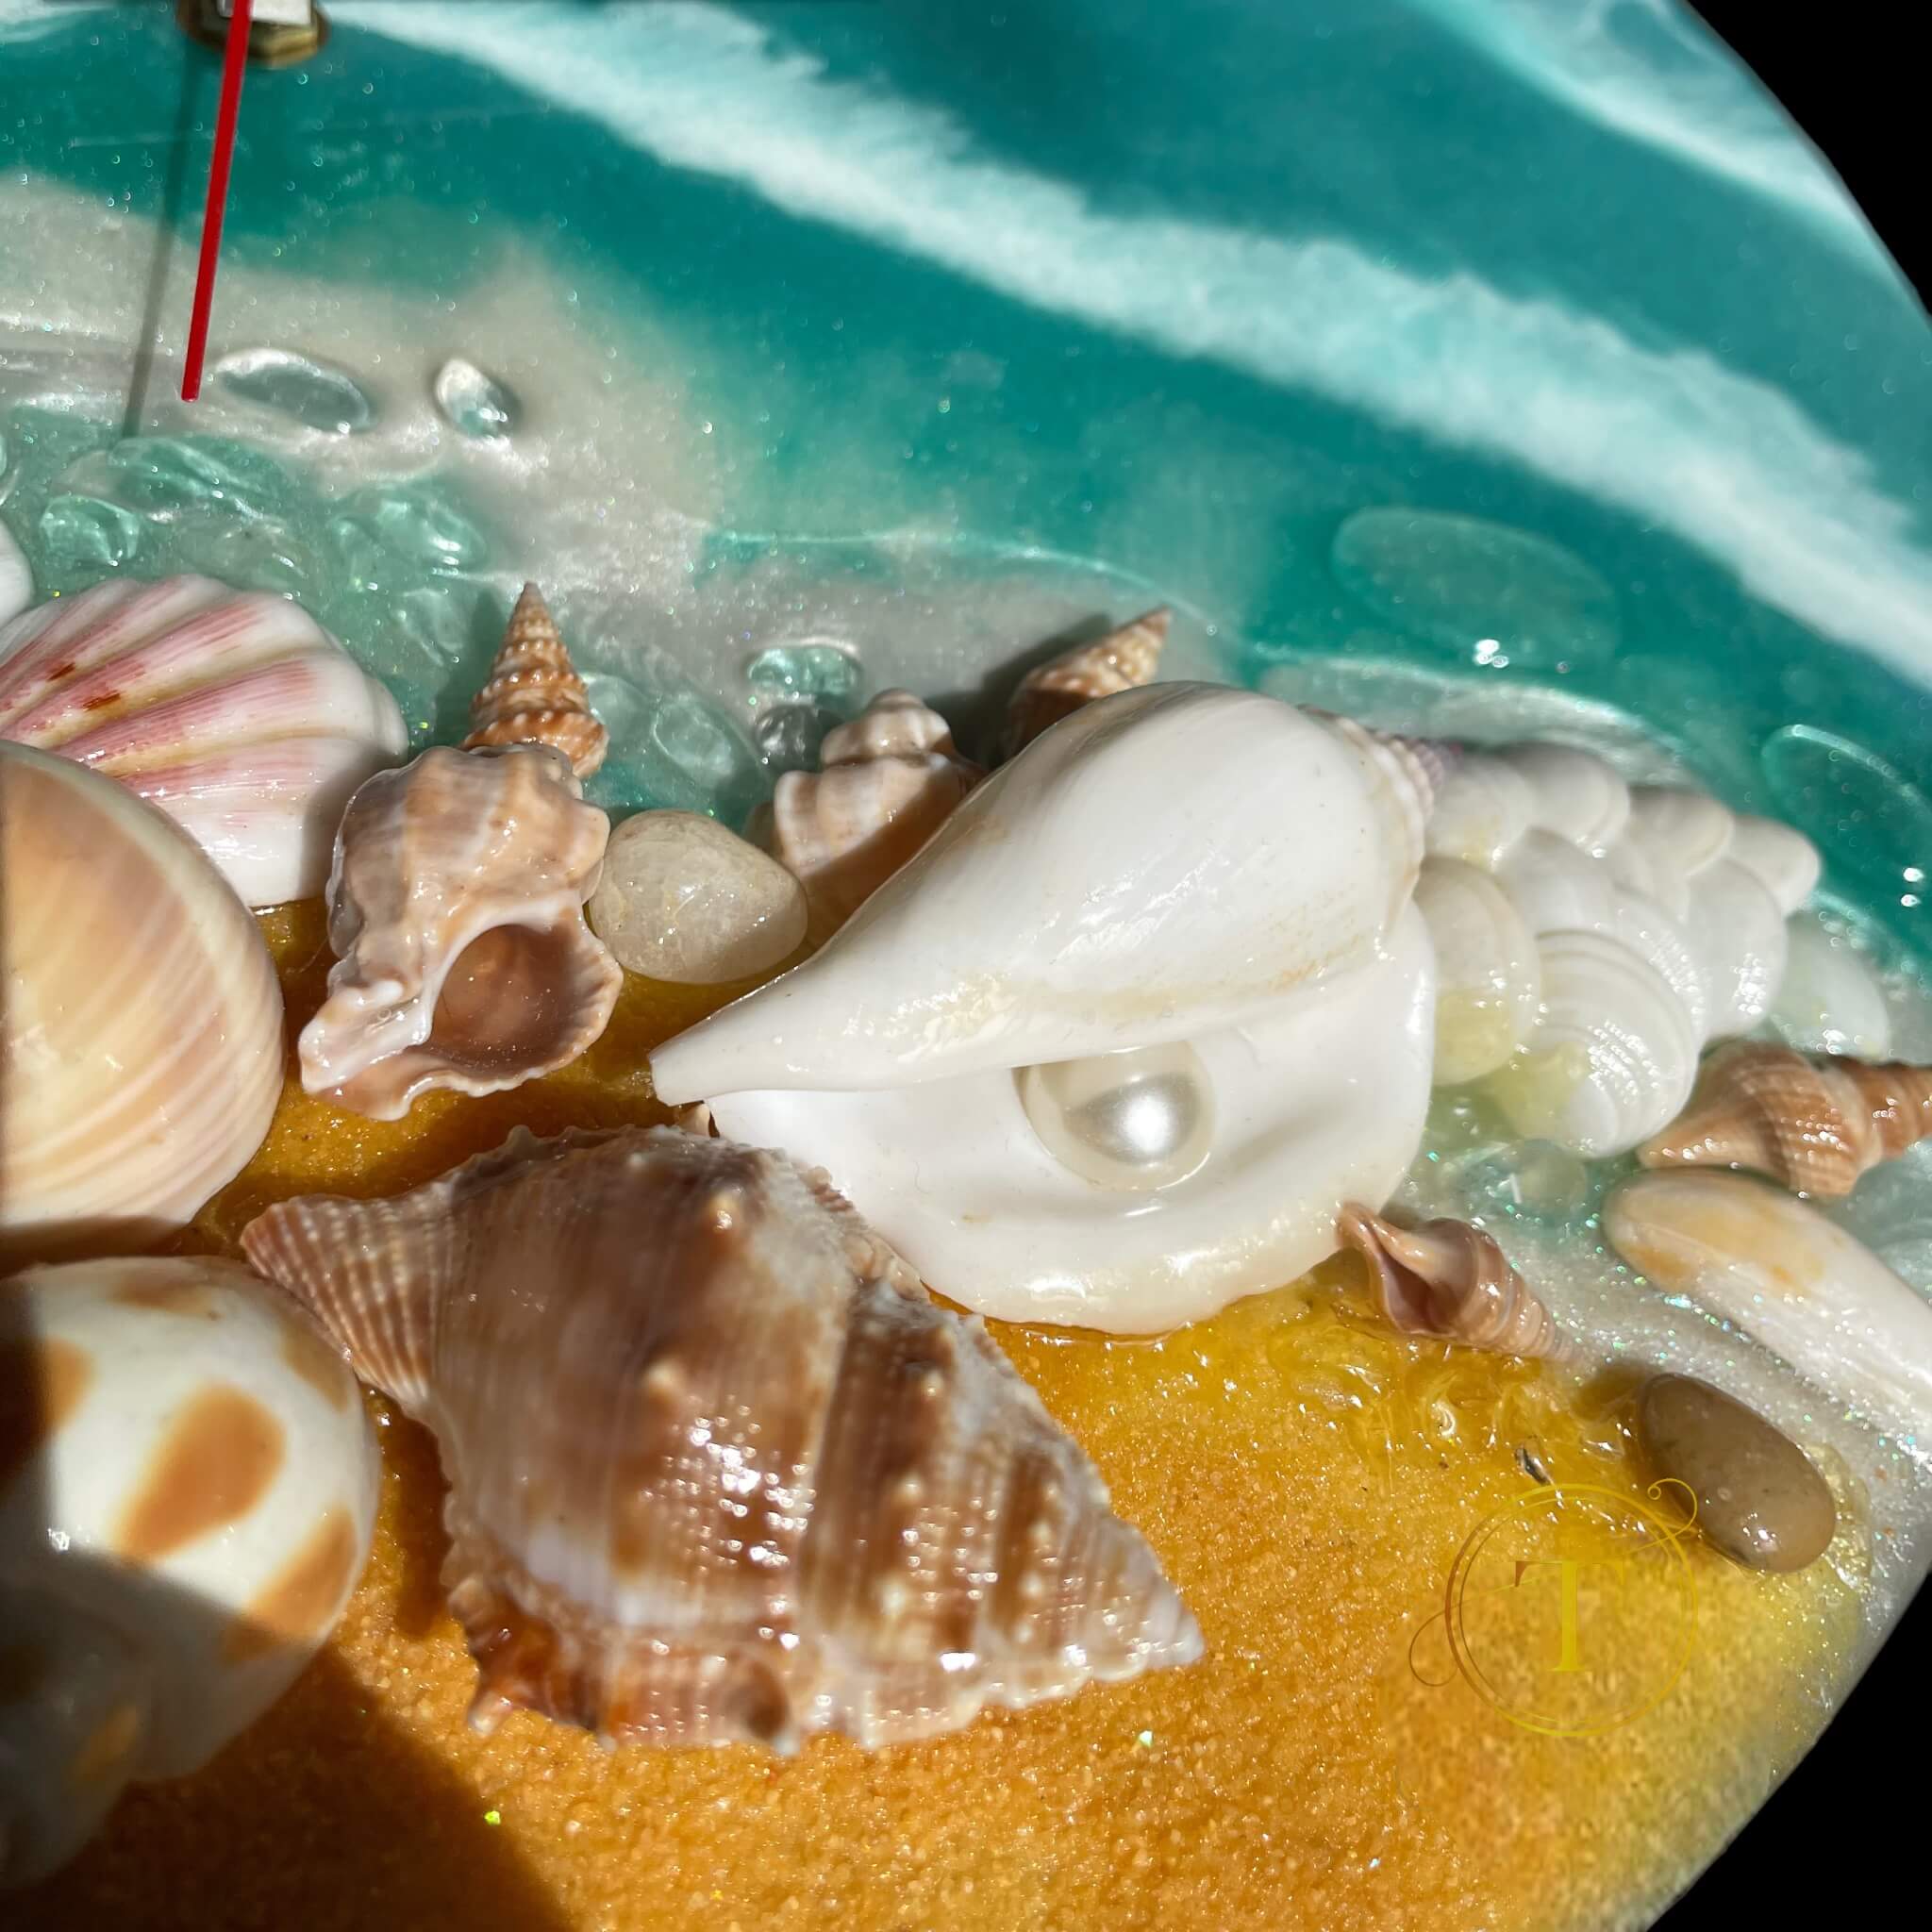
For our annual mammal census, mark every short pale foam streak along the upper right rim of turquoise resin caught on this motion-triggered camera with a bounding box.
[1410,0,1891,278]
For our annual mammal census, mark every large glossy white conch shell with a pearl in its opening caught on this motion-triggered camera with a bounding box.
[651,684,1434,1331]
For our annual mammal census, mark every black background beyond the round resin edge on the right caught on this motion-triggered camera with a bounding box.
[1657,0,1932,1932]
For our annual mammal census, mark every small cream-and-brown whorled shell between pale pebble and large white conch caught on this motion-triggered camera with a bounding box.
[771,691,985,939]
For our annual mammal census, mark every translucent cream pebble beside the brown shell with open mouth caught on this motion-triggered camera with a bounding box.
[590,811,806,985]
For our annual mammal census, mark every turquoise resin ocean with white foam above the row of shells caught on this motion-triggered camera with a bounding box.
[0,0,1932,942]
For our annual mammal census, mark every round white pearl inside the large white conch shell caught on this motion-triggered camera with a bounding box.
[1014,1040,1213,1192]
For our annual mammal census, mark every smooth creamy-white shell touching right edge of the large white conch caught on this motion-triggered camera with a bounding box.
[1416,858,1541,1086]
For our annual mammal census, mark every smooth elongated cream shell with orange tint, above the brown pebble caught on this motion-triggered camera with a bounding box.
[1604,1171,1932,1432]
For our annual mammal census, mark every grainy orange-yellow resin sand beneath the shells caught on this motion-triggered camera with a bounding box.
[8,907,1862,1932]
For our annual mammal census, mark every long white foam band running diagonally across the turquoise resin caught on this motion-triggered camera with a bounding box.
[334,0,1932,676]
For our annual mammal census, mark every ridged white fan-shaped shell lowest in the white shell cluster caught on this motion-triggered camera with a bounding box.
[1488,931,1702,1159]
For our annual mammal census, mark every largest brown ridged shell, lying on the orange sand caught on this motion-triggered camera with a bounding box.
[242,1128,1202,1750]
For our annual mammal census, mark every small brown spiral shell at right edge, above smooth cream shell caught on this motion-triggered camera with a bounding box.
[1637,1040,1932,1198]
